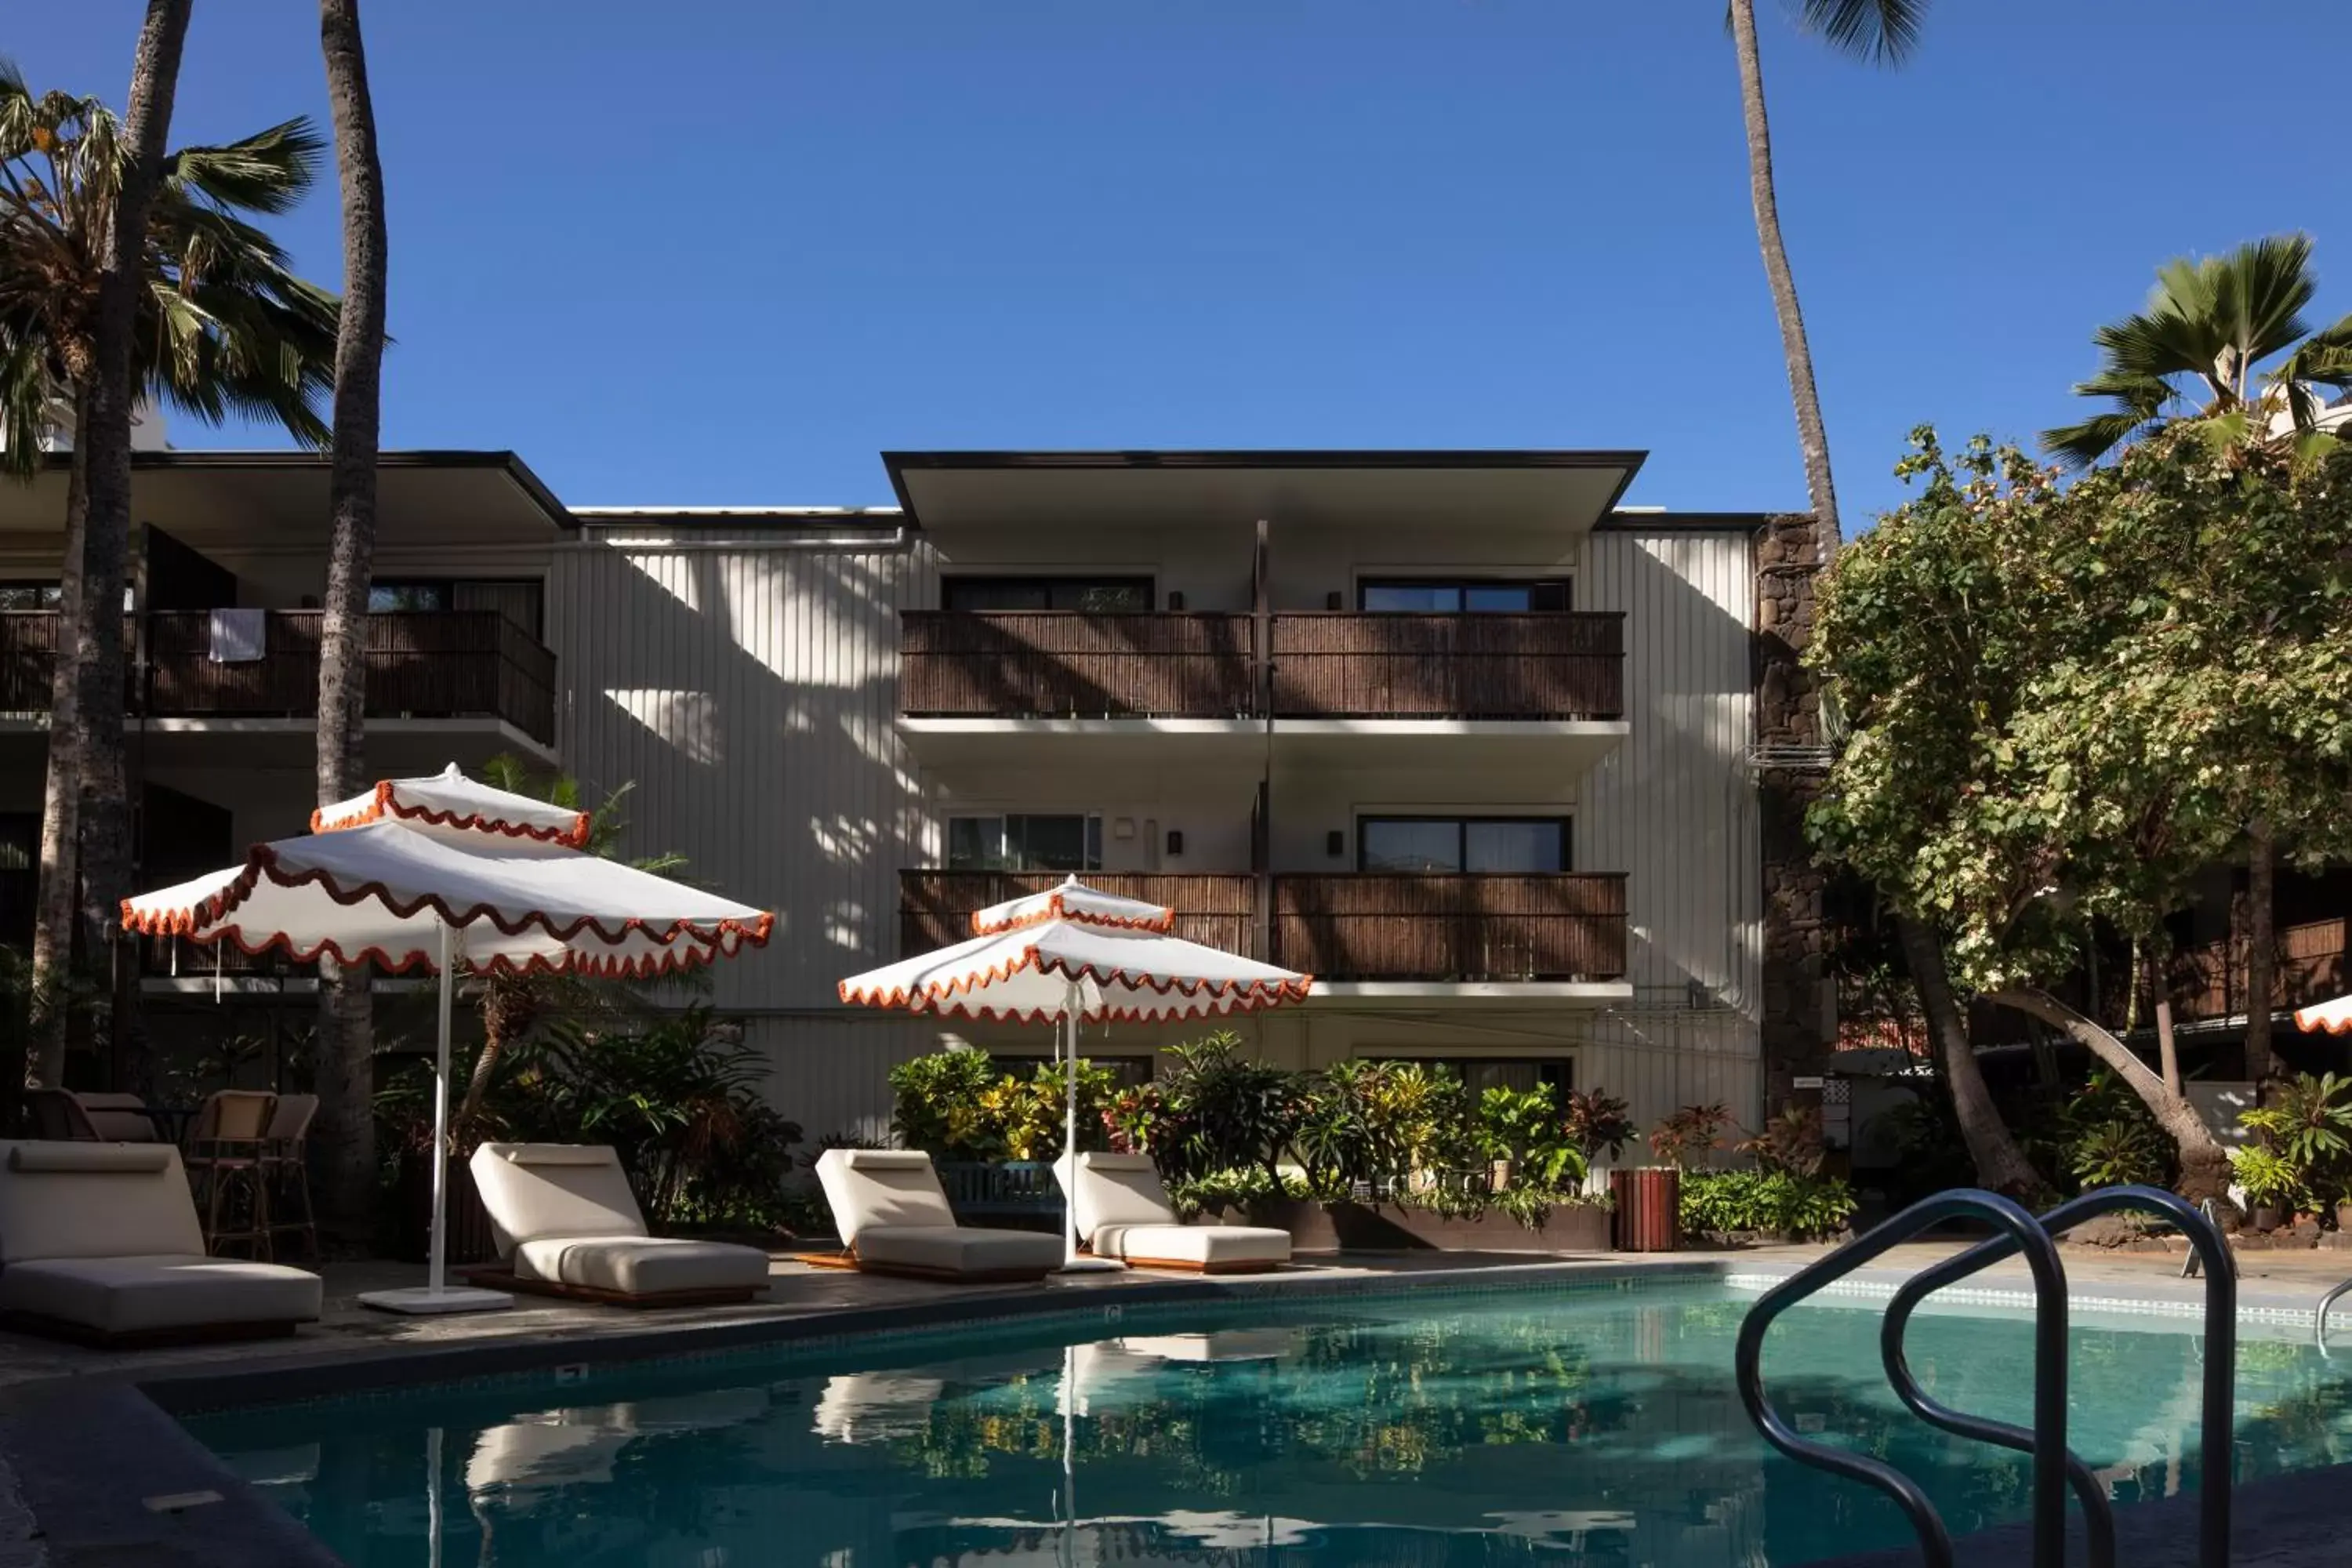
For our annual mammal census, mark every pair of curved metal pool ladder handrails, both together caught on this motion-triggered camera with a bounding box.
[1738,1187,2230,1568]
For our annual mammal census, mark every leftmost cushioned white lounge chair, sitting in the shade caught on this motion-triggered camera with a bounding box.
[0,1140,320,1347]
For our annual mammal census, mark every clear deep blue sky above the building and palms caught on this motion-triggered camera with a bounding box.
[18,0,2352,529]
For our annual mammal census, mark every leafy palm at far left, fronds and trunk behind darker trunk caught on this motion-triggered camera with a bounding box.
[0,61,336,1083]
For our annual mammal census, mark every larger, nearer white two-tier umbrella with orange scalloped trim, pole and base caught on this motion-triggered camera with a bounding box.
[122,767,774,1312]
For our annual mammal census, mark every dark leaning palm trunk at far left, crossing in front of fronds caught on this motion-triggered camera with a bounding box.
[73,0,193,1093]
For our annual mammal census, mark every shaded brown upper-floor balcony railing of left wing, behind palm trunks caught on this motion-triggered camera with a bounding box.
[0,609,555,741]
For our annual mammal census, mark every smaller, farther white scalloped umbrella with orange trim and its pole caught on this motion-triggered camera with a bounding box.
[842,877,1312,1272]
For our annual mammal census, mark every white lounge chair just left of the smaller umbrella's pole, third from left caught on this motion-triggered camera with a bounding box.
[816,1149,1061,1283]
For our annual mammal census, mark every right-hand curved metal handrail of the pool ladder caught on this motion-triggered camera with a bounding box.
[1879,1187,2237,1568]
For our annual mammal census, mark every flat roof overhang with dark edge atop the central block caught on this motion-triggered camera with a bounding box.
[882,449,1649,534]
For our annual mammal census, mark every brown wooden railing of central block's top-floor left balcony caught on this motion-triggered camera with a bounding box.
[898,612,1254,720]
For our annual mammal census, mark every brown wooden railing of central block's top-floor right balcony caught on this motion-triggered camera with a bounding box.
[1272,614,1625,720]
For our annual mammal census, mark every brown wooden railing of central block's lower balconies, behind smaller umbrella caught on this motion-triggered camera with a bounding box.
[898,869,1625,985]
